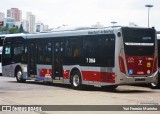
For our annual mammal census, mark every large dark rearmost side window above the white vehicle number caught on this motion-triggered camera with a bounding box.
[83,35,115,67]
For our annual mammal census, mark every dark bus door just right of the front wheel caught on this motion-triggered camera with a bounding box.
[28,43,37,78]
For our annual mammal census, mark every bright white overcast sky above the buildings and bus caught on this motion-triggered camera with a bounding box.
[0,0,160,31]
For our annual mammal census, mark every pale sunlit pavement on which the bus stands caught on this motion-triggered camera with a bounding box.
[0,77,160,114]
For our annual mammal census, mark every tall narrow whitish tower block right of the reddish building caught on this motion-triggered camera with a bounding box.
[26,12,36,33]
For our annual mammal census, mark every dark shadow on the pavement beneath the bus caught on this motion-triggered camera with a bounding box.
[8,81,154,94]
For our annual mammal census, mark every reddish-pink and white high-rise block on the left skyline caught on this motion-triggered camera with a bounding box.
[7,8,22,21]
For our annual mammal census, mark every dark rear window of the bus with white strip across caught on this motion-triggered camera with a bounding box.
[122,28,155,56]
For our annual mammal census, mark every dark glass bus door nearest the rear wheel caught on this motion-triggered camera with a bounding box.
[52,41,64,80]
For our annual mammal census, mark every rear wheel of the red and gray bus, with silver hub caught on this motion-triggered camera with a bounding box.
[71,70,83,89]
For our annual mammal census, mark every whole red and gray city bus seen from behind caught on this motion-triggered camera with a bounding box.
[2,27,158,89]
